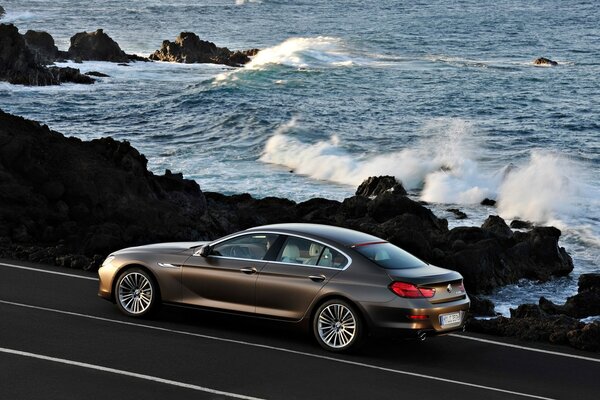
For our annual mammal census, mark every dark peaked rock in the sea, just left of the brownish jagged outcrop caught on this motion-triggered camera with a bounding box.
[68,29,129,63]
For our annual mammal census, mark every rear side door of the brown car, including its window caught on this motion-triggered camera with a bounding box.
[256,236,348,320]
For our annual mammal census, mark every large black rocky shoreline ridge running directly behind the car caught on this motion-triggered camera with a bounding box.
[0,114,573,294]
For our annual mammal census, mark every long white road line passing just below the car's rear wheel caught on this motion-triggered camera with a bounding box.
[0,300,554,400]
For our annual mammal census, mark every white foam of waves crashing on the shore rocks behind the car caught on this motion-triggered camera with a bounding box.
[260,119,600,233]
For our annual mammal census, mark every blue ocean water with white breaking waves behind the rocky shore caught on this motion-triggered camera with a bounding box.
[0,0,600,314]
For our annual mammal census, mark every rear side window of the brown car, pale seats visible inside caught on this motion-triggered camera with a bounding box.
[275,236,347,268]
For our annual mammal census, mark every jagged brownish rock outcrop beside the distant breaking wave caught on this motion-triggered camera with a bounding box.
[149,32,257,67]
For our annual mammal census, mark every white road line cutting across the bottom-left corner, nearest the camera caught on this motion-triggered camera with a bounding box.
[0,347,263,400]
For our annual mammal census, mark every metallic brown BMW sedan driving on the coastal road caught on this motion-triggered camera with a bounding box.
[98,224,469,351]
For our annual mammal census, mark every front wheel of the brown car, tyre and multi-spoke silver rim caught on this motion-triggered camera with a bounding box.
[115,268,158,317]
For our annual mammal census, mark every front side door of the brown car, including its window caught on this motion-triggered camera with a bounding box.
[182,233,277,313]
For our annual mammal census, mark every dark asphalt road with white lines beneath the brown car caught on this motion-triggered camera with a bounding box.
[0,260,600,400]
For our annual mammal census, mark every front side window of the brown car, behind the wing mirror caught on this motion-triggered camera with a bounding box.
[209,233,277,260]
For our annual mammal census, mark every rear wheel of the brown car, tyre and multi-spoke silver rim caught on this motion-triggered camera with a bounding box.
[312,299,365,353]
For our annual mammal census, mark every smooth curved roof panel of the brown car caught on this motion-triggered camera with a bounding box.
[248,223,382,247]
